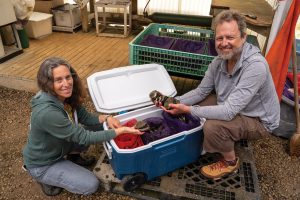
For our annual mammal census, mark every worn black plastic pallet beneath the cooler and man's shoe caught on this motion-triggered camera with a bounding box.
[94,141,261,200]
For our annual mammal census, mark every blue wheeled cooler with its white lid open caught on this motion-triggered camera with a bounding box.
[87,64,204,190]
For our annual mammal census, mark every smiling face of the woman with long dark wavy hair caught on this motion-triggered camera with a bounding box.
[52,65,73,102]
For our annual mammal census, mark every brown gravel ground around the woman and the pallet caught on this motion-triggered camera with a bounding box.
[0,87,300,200]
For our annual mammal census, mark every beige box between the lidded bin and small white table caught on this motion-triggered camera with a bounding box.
[52,4,81,28]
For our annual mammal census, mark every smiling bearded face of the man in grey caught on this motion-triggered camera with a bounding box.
[215,21,246,60]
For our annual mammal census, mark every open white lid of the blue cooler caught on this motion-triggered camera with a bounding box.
[87,64,177,113]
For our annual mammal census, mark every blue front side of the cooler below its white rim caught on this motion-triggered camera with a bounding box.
[110,130,203,180]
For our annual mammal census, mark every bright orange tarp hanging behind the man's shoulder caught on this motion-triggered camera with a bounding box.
[266,0,300,100]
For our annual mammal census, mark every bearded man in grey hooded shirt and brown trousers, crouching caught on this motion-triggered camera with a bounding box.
[161,10,280,179]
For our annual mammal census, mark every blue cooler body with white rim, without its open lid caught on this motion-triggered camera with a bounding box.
[104,106,205,180]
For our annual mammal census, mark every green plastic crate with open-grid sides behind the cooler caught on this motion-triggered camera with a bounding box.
[129,23,214,78]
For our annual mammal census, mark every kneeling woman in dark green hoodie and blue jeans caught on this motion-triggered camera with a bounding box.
[23,57,142,196]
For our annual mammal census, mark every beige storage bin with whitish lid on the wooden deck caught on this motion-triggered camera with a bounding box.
[25,12,52,39]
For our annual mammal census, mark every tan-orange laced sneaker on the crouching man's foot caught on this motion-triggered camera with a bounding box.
[200,157,240,179]
